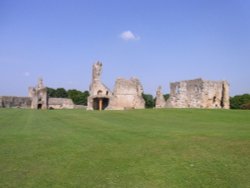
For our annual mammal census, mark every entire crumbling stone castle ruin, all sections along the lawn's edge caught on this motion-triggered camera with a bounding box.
[0,62,230,110]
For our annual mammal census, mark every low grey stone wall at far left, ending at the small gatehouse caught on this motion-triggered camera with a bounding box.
[0,96,31,108]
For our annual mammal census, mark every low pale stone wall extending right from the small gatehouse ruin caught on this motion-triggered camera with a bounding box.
[48,98,75,109]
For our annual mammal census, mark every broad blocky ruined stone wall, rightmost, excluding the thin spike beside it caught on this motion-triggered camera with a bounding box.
[166,78,229,109]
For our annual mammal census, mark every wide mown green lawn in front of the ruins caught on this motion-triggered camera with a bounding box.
[0,109,250,188]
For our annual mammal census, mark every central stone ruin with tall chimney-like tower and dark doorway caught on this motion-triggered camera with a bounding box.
[87,62,145,110]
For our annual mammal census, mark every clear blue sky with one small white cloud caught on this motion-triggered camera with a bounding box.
[0,0,250,96]
